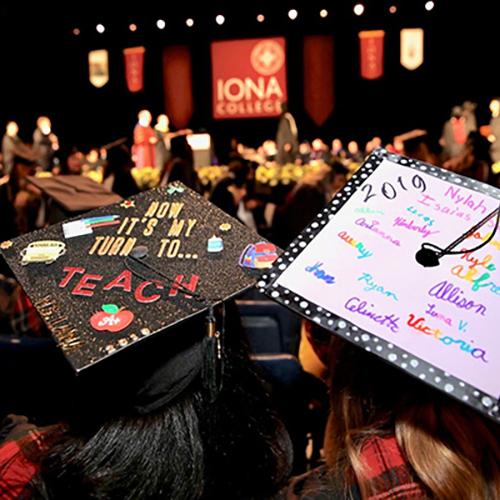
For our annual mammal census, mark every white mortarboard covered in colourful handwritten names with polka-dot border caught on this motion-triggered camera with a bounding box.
[259,149,500,421]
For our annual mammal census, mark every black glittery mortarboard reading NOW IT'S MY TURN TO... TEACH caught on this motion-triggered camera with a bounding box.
[0,183,277,371]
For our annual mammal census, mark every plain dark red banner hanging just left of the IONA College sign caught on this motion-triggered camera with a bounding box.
[163,45,194,129]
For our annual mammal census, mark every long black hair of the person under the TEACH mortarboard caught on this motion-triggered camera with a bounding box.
[25,306,290,500]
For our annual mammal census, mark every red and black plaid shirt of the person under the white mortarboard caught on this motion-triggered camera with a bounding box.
[278,436,431,500]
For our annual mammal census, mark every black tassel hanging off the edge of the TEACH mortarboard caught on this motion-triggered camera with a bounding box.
[202,307,223,403]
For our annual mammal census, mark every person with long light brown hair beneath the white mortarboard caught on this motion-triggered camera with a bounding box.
[280,325,500,500]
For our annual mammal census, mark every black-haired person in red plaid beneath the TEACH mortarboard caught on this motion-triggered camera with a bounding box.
[0,294,292,500]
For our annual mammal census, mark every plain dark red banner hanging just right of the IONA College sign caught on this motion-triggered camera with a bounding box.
[303,35,333,127]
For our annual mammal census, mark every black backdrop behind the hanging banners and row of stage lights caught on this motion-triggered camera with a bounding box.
[0,0,500,159]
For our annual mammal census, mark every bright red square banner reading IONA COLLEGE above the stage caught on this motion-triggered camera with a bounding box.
[212,38,287,120]
